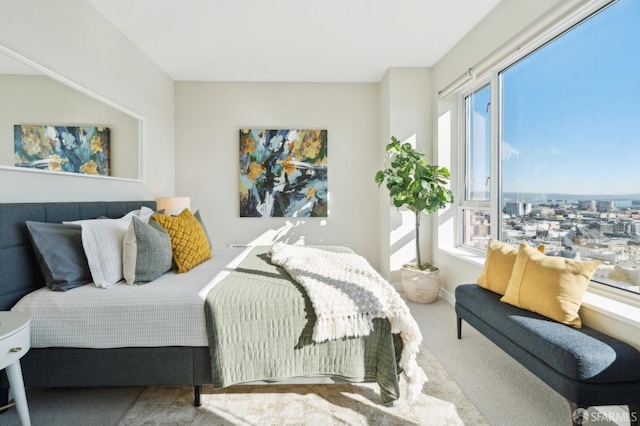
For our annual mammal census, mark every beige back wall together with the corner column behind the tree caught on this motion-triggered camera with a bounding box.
[176,68,431,272]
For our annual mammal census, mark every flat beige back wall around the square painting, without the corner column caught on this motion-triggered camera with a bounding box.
[176,82,380,266]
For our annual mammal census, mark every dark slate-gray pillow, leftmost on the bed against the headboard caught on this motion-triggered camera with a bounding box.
[26,221,93,291]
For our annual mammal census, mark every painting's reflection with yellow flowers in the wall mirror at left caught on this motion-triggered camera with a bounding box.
[13,124,110,176]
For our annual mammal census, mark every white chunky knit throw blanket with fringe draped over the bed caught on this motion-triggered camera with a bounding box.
[271,242,427,400]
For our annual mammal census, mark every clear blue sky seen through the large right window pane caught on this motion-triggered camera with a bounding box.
[502,0,640,195]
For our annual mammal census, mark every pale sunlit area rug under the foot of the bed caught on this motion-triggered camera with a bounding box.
[119,345,488,426]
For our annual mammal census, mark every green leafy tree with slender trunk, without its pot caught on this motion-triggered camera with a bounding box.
[375,136,453,270]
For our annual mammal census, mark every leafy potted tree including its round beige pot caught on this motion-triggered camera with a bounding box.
[375,136,453,303]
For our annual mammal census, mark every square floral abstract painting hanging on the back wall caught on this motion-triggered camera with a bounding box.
[240,129,328,217]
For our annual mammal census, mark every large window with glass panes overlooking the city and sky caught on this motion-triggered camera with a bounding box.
[460,0,640,293]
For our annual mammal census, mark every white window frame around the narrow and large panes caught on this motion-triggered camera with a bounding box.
[454,0,640,302]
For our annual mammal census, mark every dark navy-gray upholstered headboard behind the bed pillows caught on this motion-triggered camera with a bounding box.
[0,201,156,311]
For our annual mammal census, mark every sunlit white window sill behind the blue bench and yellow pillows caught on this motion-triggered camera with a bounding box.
[440,248,640,329]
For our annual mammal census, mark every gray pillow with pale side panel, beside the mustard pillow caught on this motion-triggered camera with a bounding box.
[122,216,173,284]
